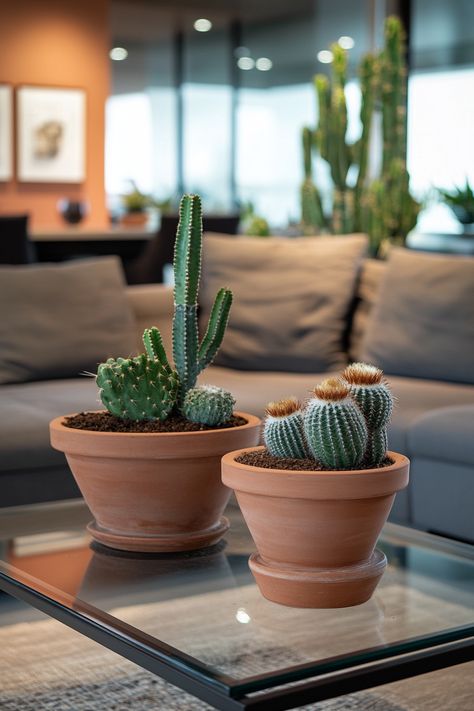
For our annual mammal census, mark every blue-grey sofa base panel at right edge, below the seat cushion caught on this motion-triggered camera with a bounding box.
[410,457,474,542]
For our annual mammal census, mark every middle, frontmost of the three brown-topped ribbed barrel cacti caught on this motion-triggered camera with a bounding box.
[304,378,368,469]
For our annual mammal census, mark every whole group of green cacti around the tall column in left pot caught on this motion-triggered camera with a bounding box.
[96,195,235,426]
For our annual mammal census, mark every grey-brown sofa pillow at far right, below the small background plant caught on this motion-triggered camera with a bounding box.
[362,249,474,383]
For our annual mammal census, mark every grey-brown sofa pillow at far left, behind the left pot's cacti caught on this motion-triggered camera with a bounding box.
[0,257,134,384]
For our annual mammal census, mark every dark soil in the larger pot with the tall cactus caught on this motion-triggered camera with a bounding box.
[63,412,247,432]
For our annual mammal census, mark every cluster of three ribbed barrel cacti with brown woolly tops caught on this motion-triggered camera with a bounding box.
[264,363,393,469]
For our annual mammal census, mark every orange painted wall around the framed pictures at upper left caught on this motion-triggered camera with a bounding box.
[0,0,109,227]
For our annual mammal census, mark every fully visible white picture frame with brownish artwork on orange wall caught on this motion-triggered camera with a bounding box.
[17,86,86,183]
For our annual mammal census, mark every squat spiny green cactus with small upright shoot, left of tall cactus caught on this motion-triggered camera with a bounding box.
[96,329,178,420]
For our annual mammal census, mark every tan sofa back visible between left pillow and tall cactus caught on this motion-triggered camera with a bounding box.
[126,284,173,359]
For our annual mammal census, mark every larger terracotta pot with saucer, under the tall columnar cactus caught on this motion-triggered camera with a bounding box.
[50,413,260,552]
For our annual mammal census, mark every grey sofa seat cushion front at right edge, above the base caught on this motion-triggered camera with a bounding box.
[408,403,474,468]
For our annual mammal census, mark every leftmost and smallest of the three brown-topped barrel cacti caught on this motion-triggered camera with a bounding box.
[263,398,308,459]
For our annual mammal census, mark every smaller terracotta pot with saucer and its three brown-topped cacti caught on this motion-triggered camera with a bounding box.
[222,363,409,607]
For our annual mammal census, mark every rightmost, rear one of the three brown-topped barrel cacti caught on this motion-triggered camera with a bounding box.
[342,363,393,466]
